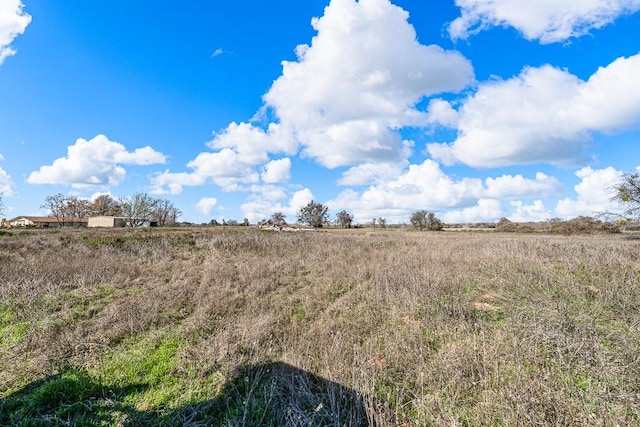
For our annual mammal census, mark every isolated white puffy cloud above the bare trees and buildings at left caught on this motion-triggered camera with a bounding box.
[27,135,166,188]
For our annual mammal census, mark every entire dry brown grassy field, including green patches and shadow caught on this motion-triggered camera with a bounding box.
[0,227,640,426]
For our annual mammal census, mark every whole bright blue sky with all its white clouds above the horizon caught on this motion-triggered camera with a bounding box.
[0,0,640,223]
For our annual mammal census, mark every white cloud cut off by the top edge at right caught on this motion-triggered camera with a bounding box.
[449,0,640,43]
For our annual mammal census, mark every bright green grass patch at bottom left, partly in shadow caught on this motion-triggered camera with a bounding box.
[0,332,225,426]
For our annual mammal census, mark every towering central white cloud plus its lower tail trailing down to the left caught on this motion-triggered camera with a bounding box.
[154,0,474,194]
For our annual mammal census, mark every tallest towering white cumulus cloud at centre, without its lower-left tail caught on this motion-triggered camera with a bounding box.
[264,0,473,168]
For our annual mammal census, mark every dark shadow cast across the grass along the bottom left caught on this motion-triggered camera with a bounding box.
[0,362,390,426]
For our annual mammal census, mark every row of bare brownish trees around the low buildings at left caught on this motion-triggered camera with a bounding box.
[40,193,182,227]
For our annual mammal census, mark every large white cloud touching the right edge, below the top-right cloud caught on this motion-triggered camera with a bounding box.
[428,54,640,171]
